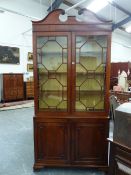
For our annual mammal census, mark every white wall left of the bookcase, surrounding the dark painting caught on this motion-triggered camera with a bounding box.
[0,12,32,80]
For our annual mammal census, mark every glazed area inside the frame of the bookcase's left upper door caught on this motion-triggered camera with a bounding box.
[37,36,67,111]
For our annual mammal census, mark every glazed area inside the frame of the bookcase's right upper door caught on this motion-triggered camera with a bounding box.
[75,36,107,111]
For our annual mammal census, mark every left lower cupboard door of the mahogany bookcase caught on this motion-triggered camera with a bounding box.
[35,122,69,165]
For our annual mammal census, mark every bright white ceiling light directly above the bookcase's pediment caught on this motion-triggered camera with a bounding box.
[87,0,112,13]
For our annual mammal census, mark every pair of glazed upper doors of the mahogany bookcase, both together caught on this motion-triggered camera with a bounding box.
[35,32,108,115]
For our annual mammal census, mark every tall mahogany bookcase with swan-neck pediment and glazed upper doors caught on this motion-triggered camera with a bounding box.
[33,9,111,170]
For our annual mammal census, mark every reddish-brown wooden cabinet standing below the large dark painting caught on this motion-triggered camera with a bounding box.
[0,73,24,102]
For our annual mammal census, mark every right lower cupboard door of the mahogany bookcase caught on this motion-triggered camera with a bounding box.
[72,120,108,166]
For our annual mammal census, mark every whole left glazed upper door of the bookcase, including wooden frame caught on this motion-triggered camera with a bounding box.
[35,32,71,115]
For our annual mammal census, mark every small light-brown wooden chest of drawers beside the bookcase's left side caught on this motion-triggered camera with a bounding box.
[25,81,34,99]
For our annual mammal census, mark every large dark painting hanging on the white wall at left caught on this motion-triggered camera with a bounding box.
[0,46,20,64]
